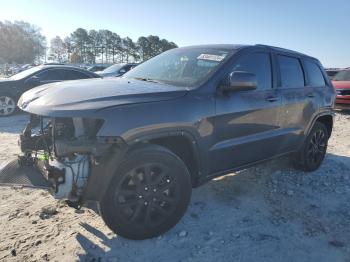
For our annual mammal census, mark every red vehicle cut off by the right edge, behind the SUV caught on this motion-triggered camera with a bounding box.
[332,69,350,109]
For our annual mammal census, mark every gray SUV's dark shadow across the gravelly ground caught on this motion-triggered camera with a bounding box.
[76,154,350,261]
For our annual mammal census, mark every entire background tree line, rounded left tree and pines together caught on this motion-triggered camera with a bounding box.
[0,21,177,64]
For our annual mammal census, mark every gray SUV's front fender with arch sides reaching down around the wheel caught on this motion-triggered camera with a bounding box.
[86,93,215,200]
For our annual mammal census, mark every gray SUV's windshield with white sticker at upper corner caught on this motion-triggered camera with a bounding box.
[124,48,230,87]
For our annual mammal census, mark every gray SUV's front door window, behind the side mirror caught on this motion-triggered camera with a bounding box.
[232,53,272,90]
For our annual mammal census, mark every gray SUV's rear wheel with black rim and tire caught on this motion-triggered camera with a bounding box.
[296,122,329,172]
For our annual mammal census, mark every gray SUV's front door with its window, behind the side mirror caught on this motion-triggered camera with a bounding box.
[210,52,281,173]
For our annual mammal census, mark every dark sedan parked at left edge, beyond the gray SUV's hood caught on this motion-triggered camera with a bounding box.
[0,65,100,117]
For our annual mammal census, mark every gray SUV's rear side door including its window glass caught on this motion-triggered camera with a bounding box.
[276,54,317,152]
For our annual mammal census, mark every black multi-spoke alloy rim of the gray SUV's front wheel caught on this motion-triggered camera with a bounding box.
[114,163,180,227]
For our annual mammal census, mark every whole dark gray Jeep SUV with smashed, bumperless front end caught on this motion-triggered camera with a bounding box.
[0,45,335,239]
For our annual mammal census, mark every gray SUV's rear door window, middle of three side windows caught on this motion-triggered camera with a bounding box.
[277,55,305,88]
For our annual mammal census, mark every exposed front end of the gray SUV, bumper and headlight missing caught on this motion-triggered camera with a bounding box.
[19,115,112,206]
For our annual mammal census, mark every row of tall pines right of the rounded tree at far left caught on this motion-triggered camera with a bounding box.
[49,28,177,64]
